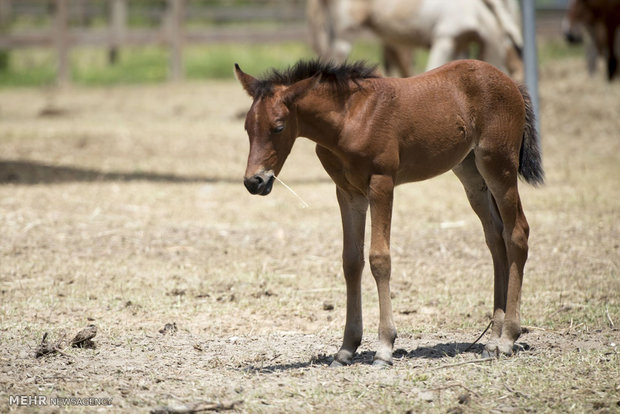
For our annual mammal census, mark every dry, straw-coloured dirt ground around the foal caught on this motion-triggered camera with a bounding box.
[0,59,620,413]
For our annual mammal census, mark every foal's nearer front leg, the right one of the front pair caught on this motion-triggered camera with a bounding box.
[368,175,396,365]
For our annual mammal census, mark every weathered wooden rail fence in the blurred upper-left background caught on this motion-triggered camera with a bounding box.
[0,0,307,84]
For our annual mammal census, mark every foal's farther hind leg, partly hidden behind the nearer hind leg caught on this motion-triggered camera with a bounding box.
[452,153,508,354]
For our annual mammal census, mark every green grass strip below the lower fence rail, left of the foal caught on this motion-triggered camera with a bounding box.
[0,42,314,87]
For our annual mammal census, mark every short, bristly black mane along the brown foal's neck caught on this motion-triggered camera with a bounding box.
[255,59,380,96]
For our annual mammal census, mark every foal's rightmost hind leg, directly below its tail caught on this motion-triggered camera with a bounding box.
[474,146,529,355]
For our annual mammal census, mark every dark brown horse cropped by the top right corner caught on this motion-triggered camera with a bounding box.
[562,0,620,81]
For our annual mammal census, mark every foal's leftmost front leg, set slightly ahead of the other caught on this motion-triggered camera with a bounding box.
[332,188,368,366]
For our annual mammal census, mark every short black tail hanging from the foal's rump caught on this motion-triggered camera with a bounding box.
[519,85,545,185]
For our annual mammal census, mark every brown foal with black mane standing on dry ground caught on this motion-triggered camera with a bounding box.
[235,60,543,365]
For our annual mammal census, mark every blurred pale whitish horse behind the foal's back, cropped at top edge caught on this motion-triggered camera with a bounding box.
[307,0,523,80]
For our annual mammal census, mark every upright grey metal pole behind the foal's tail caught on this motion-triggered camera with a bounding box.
[521,0,540,137]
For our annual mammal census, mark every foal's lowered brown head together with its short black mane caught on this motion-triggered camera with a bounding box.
[235,60,377,195]
